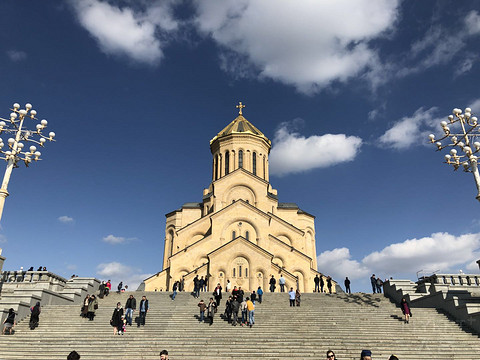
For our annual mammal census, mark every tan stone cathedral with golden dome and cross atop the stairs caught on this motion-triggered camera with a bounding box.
[144,103,335,292]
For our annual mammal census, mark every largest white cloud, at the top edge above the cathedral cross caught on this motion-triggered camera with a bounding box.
[195,0,398,93]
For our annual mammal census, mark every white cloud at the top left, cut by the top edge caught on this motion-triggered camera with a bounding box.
[71,0,178,64]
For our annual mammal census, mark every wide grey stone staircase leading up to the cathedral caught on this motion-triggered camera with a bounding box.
[0,292,480,360]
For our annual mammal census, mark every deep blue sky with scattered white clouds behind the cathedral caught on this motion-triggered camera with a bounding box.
[0,0,480,291]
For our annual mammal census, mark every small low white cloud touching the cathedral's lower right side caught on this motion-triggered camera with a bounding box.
[317,247,370,284]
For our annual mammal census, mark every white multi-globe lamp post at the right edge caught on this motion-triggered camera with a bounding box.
[429,108,480,201]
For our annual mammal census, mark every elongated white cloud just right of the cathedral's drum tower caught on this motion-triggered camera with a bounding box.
[269,123,362,176]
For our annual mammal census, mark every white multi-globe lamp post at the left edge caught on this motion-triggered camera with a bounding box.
[0,103,55,224]
